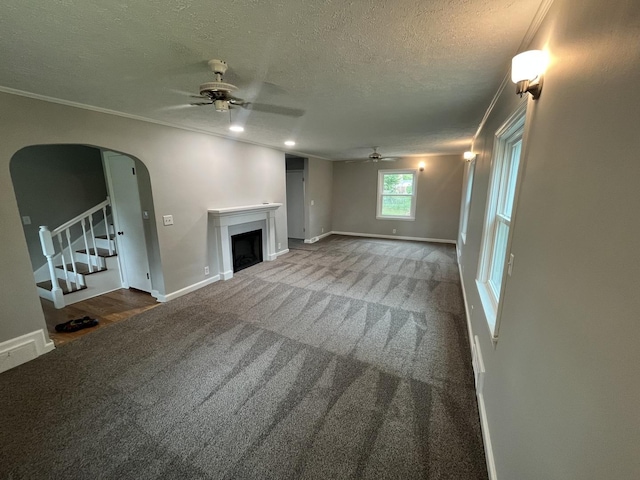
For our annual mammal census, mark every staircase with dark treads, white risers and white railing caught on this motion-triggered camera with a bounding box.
[36,197,119,308]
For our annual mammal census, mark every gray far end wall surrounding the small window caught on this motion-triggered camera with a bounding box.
[333,155,464,241]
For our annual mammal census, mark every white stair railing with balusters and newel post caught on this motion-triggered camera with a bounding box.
[39,197,113,308]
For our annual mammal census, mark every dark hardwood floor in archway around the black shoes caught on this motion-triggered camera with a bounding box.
[40,288,160,347]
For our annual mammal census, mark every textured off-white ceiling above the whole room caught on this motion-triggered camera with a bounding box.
[0,0,541,160]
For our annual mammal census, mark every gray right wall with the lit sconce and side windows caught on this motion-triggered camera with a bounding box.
[460,0,640,480]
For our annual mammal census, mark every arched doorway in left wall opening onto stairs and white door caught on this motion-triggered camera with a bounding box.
[10,145,163,334]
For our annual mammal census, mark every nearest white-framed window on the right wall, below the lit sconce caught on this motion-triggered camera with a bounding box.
[476,102,527,341]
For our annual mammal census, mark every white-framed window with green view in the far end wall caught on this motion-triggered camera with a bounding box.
[376,170,418,220]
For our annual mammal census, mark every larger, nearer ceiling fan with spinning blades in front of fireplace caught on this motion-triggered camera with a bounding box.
[191,59,304,117]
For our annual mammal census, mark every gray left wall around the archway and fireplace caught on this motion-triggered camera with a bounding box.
[0,93,287,342]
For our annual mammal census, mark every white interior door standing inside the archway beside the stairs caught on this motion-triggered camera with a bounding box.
[104,152,151,292]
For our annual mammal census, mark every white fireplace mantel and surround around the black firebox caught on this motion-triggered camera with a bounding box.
[209,203,282,280]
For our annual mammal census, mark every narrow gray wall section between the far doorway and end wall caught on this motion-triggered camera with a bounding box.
[305,157,334,239]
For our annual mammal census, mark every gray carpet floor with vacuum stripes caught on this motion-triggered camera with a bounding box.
[0,236,487,480]
